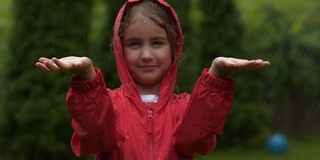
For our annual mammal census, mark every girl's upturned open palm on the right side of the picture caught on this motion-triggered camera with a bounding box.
[209,57,270,79]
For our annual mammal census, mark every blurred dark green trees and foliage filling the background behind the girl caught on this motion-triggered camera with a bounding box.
[0,0,320,160]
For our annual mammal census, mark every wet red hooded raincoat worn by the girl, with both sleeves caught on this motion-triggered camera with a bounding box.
[67,0,235,160]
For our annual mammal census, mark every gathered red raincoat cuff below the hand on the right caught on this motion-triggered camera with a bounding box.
[201,68,236,91]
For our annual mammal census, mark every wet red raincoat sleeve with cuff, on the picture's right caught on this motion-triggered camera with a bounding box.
[174,69,235,156]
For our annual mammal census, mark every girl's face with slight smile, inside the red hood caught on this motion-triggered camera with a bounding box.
[123,20,172,87]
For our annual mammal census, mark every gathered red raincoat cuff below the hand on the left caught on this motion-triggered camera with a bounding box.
[70,68,105,92]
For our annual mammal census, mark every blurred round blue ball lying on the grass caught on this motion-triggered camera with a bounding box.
[267,133,288,154]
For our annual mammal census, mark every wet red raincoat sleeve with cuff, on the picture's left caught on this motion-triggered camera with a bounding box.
[67,68,121,157]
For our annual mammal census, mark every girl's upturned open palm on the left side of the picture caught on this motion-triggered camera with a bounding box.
[36,56,96,80]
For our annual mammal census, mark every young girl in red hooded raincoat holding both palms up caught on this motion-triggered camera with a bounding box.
[36,0,270,160]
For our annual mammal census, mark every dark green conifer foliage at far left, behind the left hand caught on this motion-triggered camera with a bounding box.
[0,0,91,160]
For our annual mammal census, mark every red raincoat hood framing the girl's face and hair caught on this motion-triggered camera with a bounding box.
[113,0,183,101]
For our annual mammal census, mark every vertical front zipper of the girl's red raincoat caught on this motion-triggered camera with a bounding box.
[147,104,153,160]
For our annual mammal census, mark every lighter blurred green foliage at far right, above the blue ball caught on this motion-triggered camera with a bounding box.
[238,0,320,134]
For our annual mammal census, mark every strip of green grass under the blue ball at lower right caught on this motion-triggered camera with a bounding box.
[195,137,320,160]
